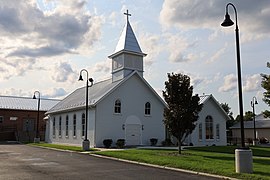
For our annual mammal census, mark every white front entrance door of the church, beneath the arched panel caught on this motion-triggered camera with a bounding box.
[126,124,141,146]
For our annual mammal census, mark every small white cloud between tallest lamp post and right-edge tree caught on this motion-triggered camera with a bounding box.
[243,74,261,92]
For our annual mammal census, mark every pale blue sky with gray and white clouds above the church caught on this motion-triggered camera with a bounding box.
[0,0,270,116]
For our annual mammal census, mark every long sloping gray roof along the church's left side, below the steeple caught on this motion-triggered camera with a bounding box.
[46,79,123,114]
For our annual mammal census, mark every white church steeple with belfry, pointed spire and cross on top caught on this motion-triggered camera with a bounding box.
[109,10,146,81]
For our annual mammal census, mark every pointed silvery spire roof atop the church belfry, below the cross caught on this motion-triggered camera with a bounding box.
[109,21,146,57]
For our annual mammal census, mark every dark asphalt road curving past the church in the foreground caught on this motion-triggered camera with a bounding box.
[0,144,219,180]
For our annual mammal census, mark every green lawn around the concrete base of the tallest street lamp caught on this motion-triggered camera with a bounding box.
[95,146,270,179]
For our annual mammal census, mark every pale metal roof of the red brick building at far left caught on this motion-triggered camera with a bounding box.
[0,96,59,111]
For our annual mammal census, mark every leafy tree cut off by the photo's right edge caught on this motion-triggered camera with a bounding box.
[261,62,270,117]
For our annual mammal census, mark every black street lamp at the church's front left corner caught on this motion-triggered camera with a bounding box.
[79,69,94,151]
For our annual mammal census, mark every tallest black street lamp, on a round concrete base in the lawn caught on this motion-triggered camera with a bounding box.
[221,3,252,173]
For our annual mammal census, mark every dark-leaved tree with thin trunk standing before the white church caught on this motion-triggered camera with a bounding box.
[163,73,202,154]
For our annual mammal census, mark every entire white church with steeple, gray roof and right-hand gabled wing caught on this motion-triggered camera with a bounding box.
[46,13,228,147]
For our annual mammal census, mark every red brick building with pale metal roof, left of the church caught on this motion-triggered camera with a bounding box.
[0,96,59,142]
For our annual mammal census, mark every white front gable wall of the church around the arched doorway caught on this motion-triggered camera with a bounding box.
[96,75,165,146]
